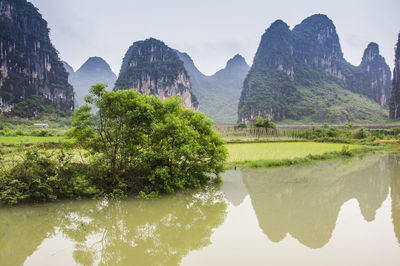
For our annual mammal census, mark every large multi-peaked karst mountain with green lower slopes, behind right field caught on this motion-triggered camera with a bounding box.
[239,15,390,123]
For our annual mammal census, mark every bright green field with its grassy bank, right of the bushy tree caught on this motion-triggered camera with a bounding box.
[223,123,400,167]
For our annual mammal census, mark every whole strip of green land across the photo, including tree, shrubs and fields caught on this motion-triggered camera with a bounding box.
[0,88,400,204]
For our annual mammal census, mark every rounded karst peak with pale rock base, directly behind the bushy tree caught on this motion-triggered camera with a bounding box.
[114,38,199,109]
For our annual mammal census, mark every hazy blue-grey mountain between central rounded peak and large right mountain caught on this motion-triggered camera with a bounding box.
[176,51,250,123]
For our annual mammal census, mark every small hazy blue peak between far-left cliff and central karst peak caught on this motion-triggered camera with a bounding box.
[63,57,117,107]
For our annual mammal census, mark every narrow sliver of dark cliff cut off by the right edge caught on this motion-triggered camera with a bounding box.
[390,34,400,119]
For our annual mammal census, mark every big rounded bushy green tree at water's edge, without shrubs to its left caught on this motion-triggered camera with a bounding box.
[70,84,227,194]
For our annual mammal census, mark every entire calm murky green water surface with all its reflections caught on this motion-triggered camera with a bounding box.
[0,154,400,265]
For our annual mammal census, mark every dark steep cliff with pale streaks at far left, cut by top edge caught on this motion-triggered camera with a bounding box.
[0,0,74,115]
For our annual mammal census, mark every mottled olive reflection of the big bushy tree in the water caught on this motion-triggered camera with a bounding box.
[60,189,226,265]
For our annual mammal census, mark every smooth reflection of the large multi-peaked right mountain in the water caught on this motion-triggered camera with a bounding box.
[242,156,389,248]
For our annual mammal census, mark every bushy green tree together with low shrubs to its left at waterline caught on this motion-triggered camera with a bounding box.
[0,84,227,204]
